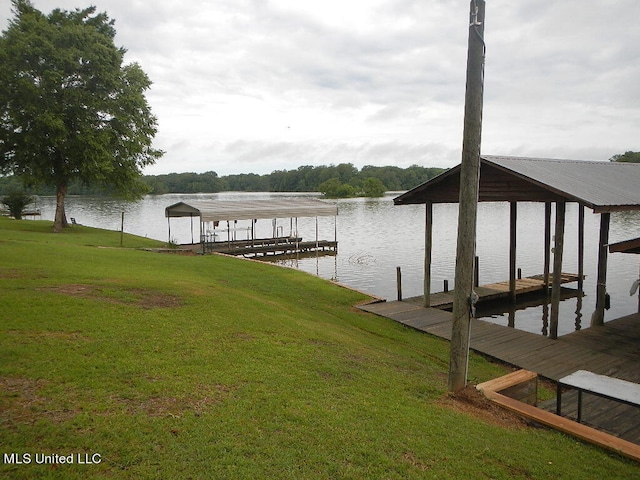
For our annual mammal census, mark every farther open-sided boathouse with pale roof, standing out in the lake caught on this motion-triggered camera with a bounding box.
[165,197,338,257]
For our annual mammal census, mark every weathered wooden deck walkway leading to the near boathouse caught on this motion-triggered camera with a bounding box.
[359,299,640,444]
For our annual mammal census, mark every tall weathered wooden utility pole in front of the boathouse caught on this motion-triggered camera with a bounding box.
[449,0,485,392]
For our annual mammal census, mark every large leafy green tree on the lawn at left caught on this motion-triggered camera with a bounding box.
[0,0,163,232]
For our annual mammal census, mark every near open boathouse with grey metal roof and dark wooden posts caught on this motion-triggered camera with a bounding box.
[394,155,640,338]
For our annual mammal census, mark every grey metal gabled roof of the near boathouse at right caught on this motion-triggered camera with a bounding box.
[394,155,640,213]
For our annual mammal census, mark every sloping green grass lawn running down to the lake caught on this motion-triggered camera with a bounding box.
[0,218,640,479]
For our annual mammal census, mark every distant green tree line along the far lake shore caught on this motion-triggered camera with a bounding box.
[0,163,444,197]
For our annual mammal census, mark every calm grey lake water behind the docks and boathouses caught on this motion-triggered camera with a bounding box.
[28,192,640,334]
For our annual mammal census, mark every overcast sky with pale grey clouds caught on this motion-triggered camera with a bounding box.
[0,0,640,175]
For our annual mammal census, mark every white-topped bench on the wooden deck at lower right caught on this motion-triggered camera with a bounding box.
[556,370,640,423]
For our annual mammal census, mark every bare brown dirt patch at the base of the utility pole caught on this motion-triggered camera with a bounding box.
[438,385,530,428]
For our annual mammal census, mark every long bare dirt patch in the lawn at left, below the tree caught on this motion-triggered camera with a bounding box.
[41,284,182,309]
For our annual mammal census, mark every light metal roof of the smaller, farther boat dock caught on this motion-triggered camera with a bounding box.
[165,198,338,222]
